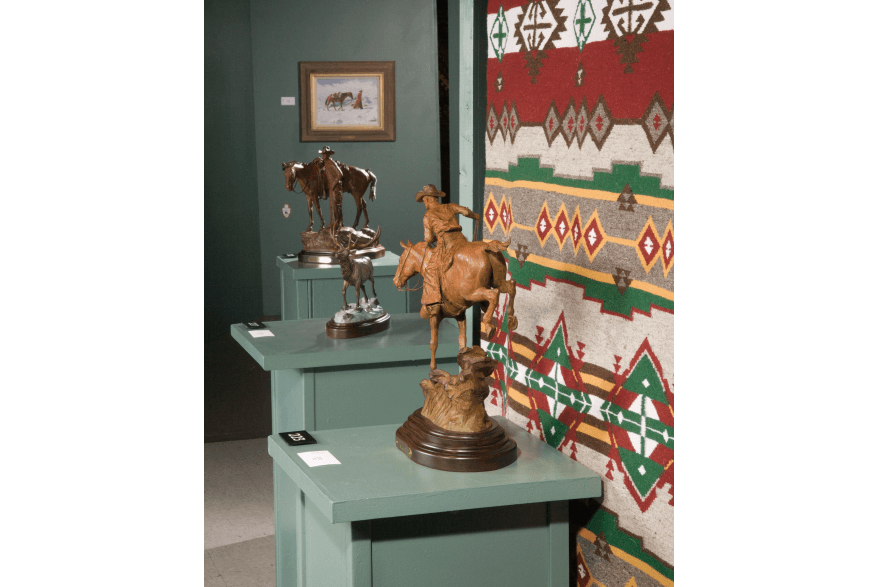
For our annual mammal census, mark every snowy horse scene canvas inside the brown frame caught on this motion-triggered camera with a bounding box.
[311,75,381,129]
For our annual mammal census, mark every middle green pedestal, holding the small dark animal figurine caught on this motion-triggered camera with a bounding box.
[231,314,460,587]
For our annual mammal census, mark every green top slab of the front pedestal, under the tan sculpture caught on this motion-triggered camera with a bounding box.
[268,418,602,524]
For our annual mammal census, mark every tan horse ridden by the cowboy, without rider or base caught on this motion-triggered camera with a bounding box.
[393,241,518,369]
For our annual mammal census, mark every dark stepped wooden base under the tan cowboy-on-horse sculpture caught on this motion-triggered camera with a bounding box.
[396,408,518,473]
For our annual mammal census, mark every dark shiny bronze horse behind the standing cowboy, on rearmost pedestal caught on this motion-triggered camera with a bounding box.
[282,157,378,232]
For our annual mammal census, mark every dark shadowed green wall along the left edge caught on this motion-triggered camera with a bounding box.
[204,0,262,341]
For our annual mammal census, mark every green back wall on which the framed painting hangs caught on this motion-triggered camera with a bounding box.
[250,0,444,315]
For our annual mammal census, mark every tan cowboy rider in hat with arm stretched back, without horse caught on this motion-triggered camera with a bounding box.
[415,184,481,318]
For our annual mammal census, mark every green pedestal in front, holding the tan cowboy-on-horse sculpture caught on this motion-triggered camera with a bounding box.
[268,417,601,587]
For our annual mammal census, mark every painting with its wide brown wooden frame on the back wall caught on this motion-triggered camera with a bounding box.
[299,61,396,142]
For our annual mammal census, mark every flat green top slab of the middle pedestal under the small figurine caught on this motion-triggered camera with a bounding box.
[231,312,460,370]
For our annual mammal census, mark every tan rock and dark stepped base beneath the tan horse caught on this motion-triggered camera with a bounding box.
[396,347,518,472]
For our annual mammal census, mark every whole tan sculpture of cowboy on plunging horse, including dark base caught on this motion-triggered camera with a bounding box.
[393,184,518,472]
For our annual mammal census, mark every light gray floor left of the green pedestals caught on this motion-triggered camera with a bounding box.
[204,438,275,587]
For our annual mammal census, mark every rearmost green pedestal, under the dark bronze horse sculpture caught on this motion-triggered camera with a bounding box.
[277,251,408,320]
